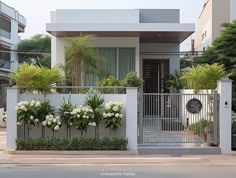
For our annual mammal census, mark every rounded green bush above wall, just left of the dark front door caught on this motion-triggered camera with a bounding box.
[121,72,143,87]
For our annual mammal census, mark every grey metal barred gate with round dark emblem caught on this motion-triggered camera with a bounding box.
[138,92,218,145]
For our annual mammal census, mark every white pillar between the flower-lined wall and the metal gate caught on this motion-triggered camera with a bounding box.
[126,88,138,150]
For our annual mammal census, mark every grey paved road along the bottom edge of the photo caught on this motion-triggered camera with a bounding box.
[0,165,236,178]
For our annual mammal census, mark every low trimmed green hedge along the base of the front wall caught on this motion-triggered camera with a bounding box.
[16,137,128,150]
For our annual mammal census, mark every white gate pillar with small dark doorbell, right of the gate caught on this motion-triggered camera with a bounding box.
[217,79,232,154]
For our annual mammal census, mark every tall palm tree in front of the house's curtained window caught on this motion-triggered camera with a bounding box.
[65,34,100,91]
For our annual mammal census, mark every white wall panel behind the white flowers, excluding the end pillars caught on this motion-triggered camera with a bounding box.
[17,94,126,138]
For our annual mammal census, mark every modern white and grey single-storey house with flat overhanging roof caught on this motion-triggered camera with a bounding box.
[46,9,195,93]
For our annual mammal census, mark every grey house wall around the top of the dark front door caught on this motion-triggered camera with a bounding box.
[140,43,180,76]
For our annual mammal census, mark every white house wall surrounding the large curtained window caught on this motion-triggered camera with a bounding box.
[52,37,139,76]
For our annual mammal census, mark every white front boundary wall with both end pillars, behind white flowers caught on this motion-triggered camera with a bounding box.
[7,87,137,150]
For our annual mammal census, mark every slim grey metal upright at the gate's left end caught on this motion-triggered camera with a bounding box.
[139,89,145,145]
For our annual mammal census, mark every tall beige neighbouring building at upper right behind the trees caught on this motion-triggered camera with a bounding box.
[195,0,236,51]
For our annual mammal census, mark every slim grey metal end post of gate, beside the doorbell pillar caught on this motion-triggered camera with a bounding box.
[213,90,218,145]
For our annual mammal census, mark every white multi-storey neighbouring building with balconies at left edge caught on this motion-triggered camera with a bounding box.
[0,1,26,108]
